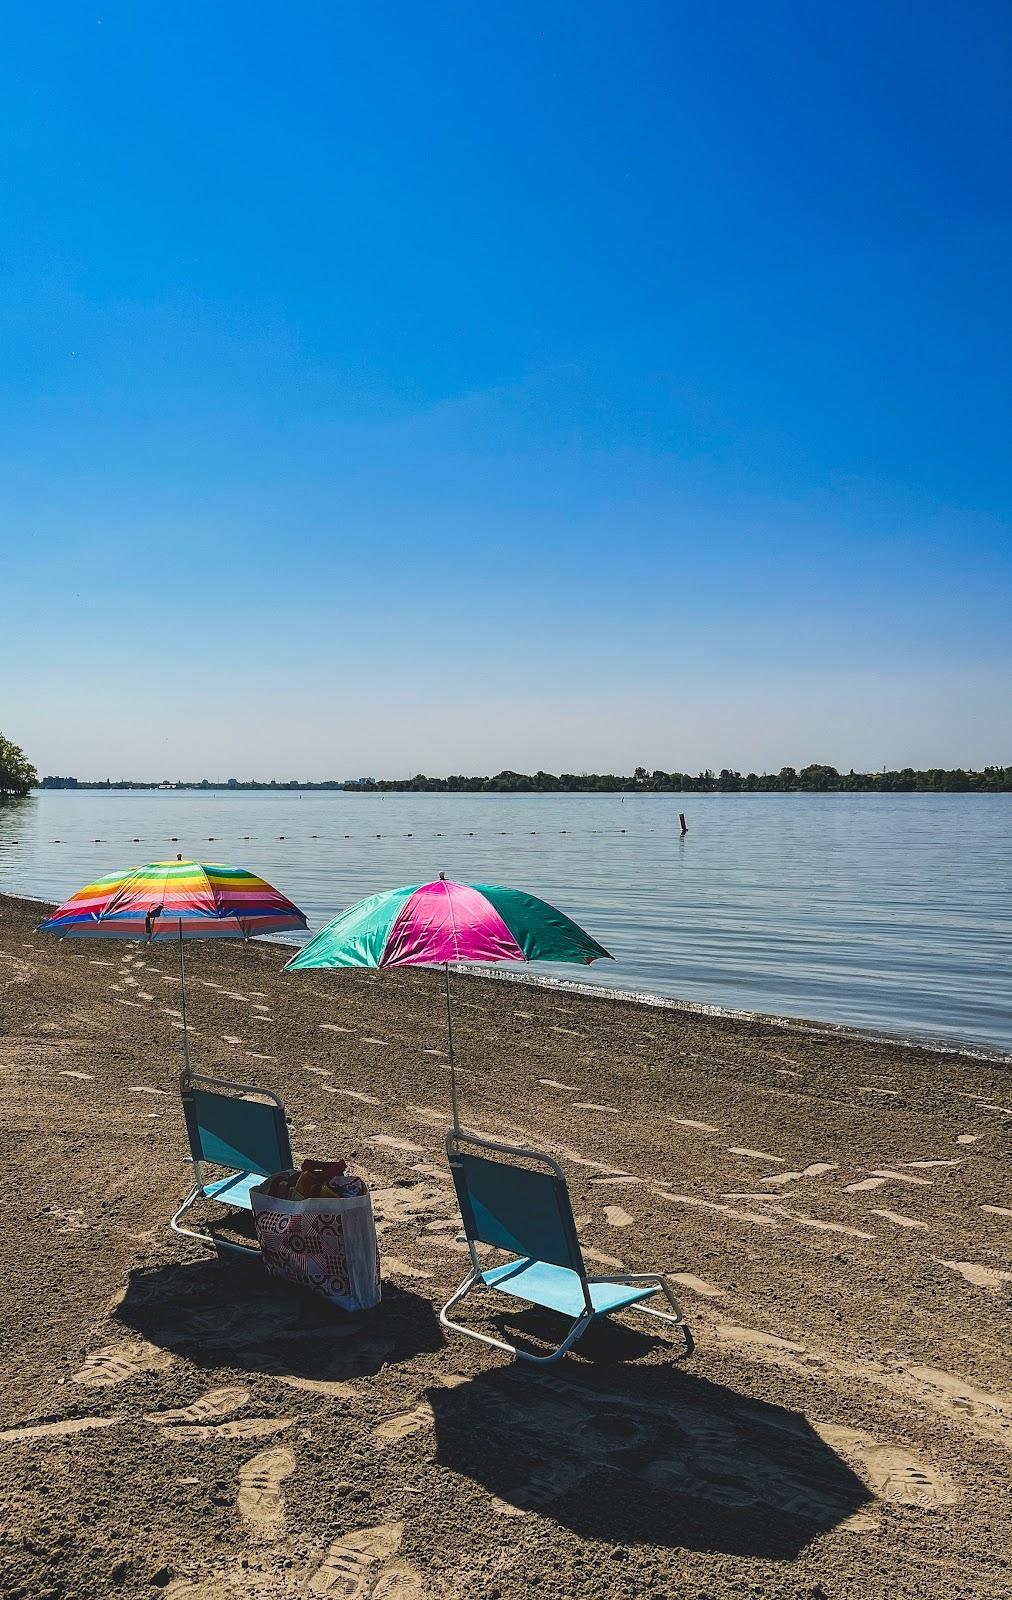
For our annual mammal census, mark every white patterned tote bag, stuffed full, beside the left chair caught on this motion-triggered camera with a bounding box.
[250,1174,381,1310]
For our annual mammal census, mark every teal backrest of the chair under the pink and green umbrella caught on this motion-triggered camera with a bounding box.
[447,1133,586,1278]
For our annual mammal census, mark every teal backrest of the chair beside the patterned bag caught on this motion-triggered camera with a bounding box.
[183,1078,291,1174]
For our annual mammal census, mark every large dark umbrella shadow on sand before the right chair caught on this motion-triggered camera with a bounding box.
[426,1317,873,1560]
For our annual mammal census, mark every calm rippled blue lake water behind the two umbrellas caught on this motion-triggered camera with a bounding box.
[0,790,1012,1050]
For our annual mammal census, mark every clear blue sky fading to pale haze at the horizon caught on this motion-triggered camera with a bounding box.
[0,0,1012,776]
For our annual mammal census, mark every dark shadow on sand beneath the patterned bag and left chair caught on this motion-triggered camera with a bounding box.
[114,1259,444,1392]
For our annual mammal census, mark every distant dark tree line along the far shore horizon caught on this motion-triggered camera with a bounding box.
[39,763,1012,794]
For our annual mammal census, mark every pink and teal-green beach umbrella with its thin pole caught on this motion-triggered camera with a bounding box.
[285,874,612,1130]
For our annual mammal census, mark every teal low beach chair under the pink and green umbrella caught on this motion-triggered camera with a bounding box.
[439,1131,695,1363]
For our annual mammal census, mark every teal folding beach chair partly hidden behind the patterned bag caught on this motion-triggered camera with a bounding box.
[170,1072,293,1256]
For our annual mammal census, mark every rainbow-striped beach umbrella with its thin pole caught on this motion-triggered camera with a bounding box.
[35,856,307,1072]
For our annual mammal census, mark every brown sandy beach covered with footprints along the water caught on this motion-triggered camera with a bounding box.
[0,899,1012,1600]
